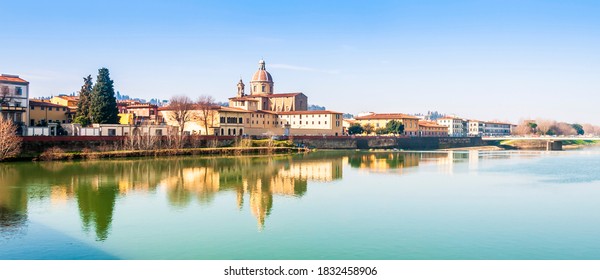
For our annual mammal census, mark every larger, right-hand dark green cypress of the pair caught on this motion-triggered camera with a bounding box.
[90,68,119,124]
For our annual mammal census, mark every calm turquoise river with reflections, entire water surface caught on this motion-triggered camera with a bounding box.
[0,149,600,260]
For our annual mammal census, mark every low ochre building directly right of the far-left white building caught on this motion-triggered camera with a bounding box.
[29,100,69,126]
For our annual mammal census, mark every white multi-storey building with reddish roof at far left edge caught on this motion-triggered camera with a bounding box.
[0,74,29,125]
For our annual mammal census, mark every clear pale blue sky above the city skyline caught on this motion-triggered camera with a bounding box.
[0,0,600,124]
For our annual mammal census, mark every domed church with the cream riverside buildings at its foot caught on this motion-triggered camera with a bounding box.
[161,60,343,136]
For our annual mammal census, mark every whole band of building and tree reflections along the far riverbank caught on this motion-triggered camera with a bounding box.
[0,151,548,241]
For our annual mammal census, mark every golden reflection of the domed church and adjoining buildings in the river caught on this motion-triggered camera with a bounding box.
[160,156,342,229]
